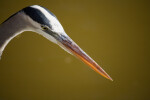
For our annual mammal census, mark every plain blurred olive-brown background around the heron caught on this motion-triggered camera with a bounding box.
[0,0,150,100]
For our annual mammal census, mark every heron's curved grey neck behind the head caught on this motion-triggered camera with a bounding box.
[0,14,25,57]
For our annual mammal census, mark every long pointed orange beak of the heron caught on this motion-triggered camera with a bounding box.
[59,35,113,81]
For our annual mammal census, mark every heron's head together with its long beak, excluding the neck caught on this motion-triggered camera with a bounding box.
[23,5,112,80]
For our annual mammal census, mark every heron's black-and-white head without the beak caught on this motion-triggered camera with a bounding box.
[23,5,66,43]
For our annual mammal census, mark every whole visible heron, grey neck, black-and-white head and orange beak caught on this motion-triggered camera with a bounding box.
[0,5,112,80]
